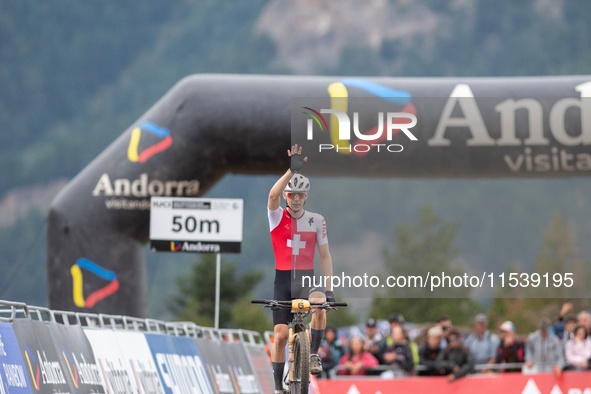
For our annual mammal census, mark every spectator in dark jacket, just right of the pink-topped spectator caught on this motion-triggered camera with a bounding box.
[378,324,414,377]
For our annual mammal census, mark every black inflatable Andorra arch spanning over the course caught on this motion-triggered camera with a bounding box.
[48,75,591,317]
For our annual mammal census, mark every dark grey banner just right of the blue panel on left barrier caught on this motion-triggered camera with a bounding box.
[196,338,262,394]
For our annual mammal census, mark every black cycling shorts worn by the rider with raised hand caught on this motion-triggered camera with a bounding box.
[273,270,324,326]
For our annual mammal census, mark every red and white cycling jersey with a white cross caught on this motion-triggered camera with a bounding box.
[267,207,328,271]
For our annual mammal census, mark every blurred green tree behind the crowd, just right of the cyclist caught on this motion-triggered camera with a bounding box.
[371,206,479,324]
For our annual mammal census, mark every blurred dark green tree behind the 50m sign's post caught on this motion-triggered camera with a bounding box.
[170,254,263,328]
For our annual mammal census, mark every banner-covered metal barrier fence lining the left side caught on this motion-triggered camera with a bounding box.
[0,300,273,394]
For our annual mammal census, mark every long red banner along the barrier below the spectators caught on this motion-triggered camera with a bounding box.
[318,371,591,394]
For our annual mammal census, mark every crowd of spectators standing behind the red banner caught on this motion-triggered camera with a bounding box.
[319,302,591,382]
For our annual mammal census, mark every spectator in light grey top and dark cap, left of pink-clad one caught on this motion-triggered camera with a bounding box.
[525,317,564,374]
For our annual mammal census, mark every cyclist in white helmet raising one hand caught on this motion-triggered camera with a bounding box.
[267,144,335,393]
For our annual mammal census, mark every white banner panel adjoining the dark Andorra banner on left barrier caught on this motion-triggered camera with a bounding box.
[84,328,138,394]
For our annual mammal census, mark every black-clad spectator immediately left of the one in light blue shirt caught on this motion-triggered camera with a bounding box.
[437,330,474,382]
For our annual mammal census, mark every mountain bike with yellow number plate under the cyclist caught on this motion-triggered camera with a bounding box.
[251,299,347,394]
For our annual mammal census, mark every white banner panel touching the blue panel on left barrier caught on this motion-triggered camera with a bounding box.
[115,331,164,394]
